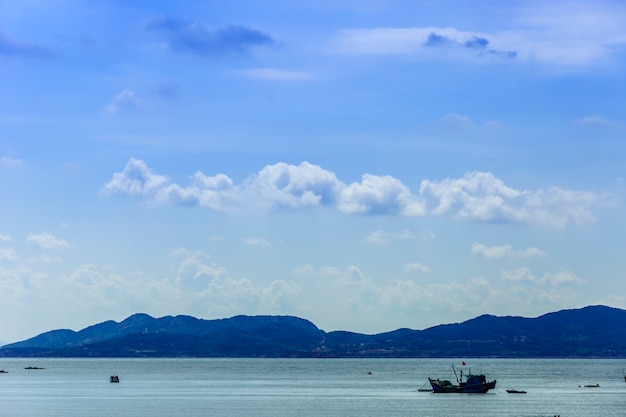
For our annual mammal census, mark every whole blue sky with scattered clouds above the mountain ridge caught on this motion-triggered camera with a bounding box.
[0,0,626,342]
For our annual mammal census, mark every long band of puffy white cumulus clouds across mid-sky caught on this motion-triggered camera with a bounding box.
[101,158,609,228]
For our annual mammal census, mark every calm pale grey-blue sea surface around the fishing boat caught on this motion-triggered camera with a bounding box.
[0,358,626,417]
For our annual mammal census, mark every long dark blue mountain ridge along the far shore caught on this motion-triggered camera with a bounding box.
[0,306,626,358]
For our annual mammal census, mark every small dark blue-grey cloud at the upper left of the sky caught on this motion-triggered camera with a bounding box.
[145,16,274,56]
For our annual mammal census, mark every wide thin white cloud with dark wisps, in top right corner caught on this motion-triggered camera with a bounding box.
[330,2,626,68]
